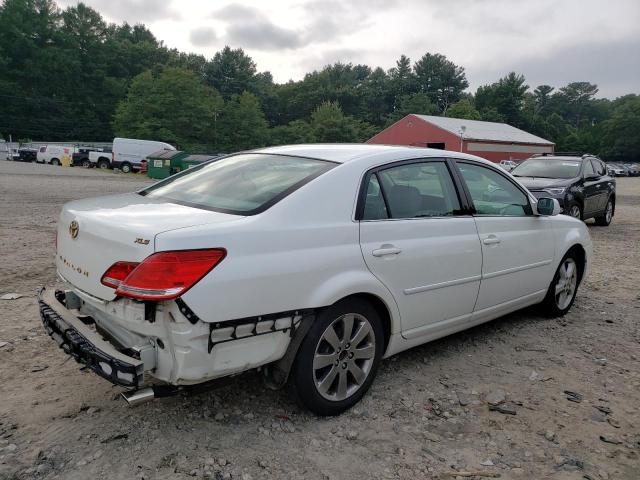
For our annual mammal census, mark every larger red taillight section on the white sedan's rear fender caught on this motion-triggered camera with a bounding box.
[112,248,227,300]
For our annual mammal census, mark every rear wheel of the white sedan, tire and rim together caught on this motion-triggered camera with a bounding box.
[289,298,384,416]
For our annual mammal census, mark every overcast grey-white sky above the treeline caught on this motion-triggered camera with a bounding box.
[59,0,640,98]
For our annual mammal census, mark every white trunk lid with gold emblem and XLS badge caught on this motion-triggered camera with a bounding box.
[56,193,245,300]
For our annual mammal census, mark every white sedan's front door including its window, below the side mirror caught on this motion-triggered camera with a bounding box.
[456,161,555,311]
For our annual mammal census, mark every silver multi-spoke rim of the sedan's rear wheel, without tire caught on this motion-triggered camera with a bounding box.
[313,313,376,401]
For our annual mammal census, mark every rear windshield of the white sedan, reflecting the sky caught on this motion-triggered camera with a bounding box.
[140,153,335,215]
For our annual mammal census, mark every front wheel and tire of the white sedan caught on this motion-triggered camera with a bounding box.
[541,251,582,317]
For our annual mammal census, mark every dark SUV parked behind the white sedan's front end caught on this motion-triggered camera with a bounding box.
[511,154,616,226]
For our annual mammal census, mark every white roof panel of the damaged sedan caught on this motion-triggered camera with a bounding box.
[252,143,495,166]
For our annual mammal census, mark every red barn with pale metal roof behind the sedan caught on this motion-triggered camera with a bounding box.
[367,113,554,162]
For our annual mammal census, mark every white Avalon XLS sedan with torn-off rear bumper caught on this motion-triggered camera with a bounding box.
[40,145,591,415]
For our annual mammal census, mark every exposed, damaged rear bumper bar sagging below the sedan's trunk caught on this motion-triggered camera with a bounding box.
[38,289,144,388]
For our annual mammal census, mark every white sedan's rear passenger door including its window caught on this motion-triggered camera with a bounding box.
[358,160,482,338]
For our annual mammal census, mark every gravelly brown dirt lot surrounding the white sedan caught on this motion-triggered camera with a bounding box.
[0,162,640,480]
